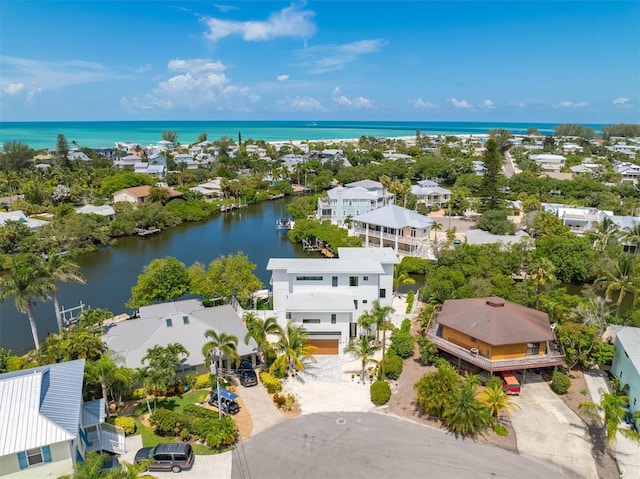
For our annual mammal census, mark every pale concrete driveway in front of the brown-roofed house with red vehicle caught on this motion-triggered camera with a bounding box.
[510,372,598,479]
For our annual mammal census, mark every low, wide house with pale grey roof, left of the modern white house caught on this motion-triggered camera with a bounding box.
[102,299,257,373]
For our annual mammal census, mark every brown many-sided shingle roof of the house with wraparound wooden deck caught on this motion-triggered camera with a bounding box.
[438,296,553,346]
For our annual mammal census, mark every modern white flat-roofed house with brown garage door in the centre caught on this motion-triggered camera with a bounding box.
[267,248,400,354]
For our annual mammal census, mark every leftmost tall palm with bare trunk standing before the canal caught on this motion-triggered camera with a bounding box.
[0,253,53,351]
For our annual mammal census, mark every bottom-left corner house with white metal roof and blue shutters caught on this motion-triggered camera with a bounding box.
[0,359,126,479]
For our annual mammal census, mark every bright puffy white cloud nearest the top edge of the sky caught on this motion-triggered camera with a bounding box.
[203,5,317,42]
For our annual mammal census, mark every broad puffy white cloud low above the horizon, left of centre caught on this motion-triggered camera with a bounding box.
[120,58,260,111]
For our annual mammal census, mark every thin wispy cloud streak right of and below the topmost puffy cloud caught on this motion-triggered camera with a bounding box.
[297,39,388,73]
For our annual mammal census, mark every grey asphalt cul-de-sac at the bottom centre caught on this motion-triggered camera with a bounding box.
[231,412,563,479]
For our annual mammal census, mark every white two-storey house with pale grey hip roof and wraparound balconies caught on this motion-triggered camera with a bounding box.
[349,205,435,257]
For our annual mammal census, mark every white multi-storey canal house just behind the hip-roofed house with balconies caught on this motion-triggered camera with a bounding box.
[316,180,394,226]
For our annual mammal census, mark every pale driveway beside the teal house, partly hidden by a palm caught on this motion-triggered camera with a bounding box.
[584,369,640,478]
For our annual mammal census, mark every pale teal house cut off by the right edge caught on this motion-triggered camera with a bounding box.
[611,326,640,427]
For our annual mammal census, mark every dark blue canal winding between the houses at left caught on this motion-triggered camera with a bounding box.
[0,198,307,353]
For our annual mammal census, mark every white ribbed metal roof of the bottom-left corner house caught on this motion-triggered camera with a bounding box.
[0,359,84,456]
